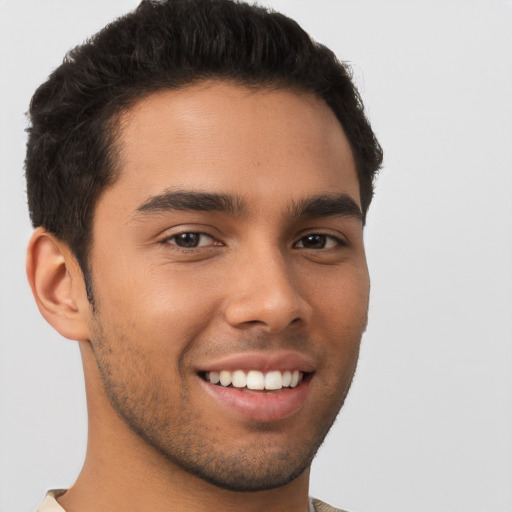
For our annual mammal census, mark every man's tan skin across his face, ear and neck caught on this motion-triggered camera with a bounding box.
[27,82,369,512]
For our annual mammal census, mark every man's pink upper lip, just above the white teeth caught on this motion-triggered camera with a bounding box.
[197,350,315,373]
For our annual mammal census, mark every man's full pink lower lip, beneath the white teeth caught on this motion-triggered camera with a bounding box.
[198,377,310,422]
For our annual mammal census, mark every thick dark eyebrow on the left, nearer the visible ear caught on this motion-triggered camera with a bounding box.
[136,190,245,215]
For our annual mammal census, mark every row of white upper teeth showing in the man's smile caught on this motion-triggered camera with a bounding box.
[205,370,303,391]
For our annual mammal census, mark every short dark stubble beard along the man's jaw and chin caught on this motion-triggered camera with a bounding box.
[91,322,355,492]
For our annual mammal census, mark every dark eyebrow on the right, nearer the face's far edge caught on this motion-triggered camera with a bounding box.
[290,194,363,222]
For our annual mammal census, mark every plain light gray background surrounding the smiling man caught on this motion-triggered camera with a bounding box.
[0,0,512,512]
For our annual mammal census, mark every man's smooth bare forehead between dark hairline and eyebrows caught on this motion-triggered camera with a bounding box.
[101,82,359,216]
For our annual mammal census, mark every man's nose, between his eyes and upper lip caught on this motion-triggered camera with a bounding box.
[225,249,312,333]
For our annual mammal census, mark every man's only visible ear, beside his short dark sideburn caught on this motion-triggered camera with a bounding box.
[27,228,91,341]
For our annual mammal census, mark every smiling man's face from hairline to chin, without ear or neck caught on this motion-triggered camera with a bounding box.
[90,83,369,490]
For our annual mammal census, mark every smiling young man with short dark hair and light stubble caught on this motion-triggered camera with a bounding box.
[26,0,382,512]
